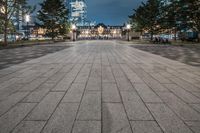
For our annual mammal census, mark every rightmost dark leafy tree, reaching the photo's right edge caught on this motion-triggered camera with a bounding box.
[161,0,200,40]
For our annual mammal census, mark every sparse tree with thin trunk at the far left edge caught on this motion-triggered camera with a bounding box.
[0,0,31,45]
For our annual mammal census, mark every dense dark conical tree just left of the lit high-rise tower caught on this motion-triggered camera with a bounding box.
[37,0,68,40]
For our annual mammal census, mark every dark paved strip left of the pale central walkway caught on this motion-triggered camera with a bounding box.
[0,43,71,69]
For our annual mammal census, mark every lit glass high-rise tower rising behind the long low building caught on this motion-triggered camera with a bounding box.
[66,0,93,26]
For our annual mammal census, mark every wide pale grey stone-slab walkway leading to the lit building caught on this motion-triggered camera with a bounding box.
[0,41,200,133]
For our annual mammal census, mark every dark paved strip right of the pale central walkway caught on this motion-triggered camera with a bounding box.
[132,44,200,67]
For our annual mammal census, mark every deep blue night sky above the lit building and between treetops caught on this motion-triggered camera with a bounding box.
[29,0,146,25]
